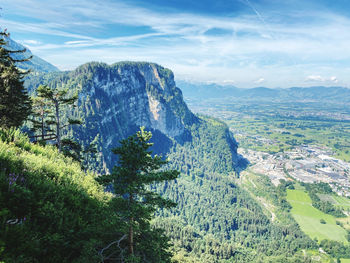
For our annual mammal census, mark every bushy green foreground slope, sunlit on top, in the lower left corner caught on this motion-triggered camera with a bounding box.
[0,130,175,263]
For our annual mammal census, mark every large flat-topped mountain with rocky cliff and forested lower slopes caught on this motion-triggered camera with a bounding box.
[25,62,320,263]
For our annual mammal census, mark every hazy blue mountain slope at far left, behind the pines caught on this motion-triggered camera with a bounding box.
[2,37,59,72]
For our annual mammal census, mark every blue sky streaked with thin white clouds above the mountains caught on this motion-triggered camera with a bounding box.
[0,0,350,88]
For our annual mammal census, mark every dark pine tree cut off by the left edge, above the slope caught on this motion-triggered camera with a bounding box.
[0,31,31,128]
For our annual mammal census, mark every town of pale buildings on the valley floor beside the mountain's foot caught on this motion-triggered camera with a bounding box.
[240,145,350,196]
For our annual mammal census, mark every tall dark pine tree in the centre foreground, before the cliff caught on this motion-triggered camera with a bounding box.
[97,128,179,262]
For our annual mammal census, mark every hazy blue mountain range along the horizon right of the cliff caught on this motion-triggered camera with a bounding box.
[177,80,350,103]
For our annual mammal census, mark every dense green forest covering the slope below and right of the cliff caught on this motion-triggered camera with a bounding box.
[155,118,314,263]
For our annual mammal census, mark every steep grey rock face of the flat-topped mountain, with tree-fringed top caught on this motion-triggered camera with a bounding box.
[68,62,198,168]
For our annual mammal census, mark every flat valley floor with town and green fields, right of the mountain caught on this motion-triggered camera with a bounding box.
[186,98,350,262]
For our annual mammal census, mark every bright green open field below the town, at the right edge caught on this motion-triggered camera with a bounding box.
[287,190,348,243]
